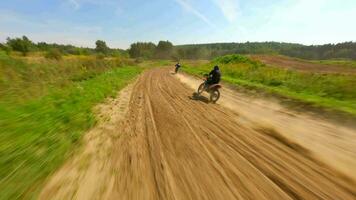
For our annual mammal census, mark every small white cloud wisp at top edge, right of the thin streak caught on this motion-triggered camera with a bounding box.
[212,0,239,22]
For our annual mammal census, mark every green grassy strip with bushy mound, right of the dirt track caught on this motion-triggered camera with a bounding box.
[183,55,356,116]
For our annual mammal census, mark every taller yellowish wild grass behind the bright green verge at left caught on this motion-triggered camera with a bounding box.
[0,54,137,101]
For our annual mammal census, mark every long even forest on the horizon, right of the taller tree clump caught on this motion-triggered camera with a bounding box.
[175,42,356,60]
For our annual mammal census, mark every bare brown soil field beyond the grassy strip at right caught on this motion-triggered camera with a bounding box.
[251,55,356,74]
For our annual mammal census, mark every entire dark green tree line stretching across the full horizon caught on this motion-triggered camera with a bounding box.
[0,36,356,60]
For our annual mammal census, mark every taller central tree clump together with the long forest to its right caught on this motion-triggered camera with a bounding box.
[128,41,356,60]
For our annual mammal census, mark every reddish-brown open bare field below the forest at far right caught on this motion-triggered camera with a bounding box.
[250,55,356,75]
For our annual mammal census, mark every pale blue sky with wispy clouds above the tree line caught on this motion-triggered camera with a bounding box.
[0,0,356,49]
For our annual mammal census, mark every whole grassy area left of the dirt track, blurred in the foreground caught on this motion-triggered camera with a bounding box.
[0,54,143,199]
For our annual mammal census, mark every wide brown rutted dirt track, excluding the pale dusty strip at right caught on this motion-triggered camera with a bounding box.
[40,69,356,199]
